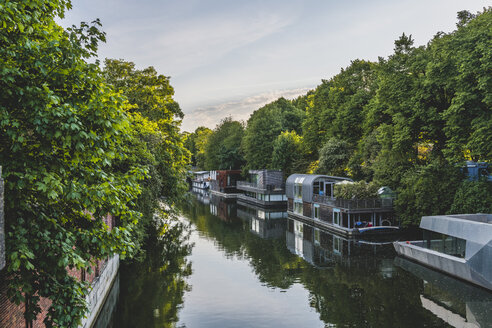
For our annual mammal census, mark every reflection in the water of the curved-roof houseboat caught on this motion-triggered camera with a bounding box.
[286,218,393,270]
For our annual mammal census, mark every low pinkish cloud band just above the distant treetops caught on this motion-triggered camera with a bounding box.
[182,87,312,131]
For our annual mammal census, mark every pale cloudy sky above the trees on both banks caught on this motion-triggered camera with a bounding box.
[60,0,490,132]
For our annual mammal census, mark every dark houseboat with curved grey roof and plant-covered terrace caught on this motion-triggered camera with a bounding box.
[286,174,398,236]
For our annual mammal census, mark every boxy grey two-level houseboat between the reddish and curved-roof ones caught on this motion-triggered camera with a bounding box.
[237,170,287,207]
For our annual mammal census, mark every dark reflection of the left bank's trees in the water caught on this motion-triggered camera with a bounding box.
[115,218,193,327]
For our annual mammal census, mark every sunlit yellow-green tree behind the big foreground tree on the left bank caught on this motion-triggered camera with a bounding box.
[104,59,189,202]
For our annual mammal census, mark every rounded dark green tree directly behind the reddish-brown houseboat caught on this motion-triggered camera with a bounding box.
[205,117,244,170]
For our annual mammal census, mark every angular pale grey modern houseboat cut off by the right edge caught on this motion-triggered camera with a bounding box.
[393,214,492,290]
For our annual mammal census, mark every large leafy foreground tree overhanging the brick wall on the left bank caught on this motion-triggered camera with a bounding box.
[0,0,147,327]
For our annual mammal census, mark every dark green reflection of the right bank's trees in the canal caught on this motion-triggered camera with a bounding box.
[184,199,447,328]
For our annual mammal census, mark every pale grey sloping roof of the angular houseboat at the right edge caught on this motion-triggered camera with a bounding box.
[420,213,492,246]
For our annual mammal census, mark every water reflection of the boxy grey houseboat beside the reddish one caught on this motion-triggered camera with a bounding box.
[237,204,287,239]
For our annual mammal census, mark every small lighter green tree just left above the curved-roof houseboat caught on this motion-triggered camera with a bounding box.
[271,131,304,178]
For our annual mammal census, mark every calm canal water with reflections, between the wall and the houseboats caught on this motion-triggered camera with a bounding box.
[96,195,492,328]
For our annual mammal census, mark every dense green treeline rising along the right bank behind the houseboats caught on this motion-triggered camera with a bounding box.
[186,8,492,224]
